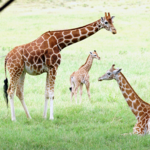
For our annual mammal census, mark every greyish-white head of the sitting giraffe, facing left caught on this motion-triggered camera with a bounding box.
[98,64,121,81]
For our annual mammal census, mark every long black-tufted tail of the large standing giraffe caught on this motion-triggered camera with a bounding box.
[3,59,8,108]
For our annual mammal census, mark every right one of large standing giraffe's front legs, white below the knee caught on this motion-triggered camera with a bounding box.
[49,67,57,120]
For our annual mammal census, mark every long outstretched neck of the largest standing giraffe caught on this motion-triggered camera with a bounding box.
[54,19,103,49]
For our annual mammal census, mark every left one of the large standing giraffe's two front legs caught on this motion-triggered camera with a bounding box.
[43,73,50,119]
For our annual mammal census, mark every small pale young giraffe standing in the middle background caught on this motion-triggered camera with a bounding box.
[69,50,100,103]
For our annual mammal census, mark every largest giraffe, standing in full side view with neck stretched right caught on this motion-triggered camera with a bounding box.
[4,13,117,121]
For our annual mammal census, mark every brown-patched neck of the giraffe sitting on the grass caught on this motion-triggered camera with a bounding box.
[116,73,150,119]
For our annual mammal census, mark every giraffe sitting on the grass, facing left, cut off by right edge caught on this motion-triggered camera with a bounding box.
[98,65,150,135]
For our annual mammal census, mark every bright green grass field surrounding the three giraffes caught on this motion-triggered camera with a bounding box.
[0,0,150,150]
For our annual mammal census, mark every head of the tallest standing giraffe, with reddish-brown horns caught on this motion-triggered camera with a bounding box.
[101,12,117,34]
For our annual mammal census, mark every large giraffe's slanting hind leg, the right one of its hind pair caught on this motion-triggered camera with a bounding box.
[16,72,31,119]
